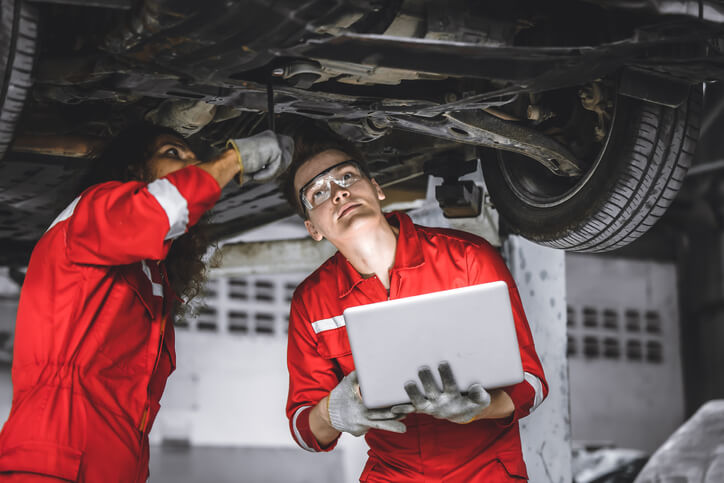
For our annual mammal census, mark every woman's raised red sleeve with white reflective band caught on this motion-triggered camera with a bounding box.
[65,166,221,265]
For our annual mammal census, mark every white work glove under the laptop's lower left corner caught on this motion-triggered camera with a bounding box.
[329,371,415,436]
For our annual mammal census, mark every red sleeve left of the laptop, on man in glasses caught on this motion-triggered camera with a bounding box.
[287,293,340,452]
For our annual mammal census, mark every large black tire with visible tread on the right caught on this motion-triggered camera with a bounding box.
[483,86,702,252]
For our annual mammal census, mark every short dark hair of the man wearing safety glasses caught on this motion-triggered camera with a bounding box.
[279,124,371,219]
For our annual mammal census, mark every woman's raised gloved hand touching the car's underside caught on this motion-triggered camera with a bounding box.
[226,130,294,184]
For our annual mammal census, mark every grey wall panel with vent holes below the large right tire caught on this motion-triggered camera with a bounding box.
[566,254,684,451]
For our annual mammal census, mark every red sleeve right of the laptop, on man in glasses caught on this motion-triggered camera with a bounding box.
[466,242,548,425]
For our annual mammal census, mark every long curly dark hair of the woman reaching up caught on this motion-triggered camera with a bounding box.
[82,122,210,302]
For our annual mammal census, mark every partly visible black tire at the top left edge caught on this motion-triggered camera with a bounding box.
[0,0,38,159]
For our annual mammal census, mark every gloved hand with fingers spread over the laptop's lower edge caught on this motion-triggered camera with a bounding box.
[390,362,490,424]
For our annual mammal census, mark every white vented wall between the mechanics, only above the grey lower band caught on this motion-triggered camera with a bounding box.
[151,274,304,447]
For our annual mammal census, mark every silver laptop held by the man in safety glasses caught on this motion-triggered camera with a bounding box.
[343,281,523,408]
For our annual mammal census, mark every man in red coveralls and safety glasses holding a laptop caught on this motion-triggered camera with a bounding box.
[283,126,548,483]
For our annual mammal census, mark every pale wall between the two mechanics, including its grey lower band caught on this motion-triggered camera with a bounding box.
[150,273,360,483]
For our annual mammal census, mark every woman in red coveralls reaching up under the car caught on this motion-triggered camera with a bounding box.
[0,124,293,483]
